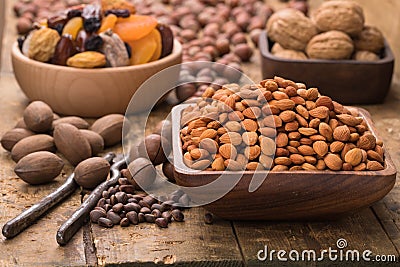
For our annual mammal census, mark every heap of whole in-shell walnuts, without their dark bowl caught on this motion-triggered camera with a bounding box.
[267,0,384,61]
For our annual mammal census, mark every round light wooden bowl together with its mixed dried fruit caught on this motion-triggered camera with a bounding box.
[11,3,182,117]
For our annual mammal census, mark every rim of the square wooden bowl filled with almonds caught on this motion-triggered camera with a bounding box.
[171,103,397,178]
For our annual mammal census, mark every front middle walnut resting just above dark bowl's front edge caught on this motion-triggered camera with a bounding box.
[306,31,354,59]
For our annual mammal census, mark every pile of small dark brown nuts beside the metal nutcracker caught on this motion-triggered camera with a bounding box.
[90,177,189,228]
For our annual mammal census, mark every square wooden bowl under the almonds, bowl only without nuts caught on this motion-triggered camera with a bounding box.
[172,104,396,220]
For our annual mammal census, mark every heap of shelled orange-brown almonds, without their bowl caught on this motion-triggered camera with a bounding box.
[180,77,384,171]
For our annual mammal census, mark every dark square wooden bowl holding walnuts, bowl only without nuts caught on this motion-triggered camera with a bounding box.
[259,32,394,105]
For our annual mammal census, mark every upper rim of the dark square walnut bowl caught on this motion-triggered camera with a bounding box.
[259,30,394,65]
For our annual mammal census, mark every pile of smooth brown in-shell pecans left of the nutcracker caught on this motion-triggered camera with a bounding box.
[0,101,124,184]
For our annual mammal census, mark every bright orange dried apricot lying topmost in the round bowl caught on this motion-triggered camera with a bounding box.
[114,15,157,42]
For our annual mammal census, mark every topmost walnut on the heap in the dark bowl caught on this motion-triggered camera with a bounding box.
[312,0,365,36]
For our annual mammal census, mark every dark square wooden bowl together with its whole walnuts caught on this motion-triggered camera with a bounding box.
[259,1,394,104]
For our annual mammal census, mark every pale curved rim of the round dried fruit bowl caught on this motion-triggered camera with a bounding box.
[11,39,183,74]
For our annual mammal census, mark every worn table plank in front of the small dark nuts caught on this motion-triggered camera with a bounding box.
[92,208,242,266]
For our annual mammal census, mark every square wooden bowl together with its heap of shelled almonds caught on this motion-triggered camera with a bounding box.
[172,77,396,220]
